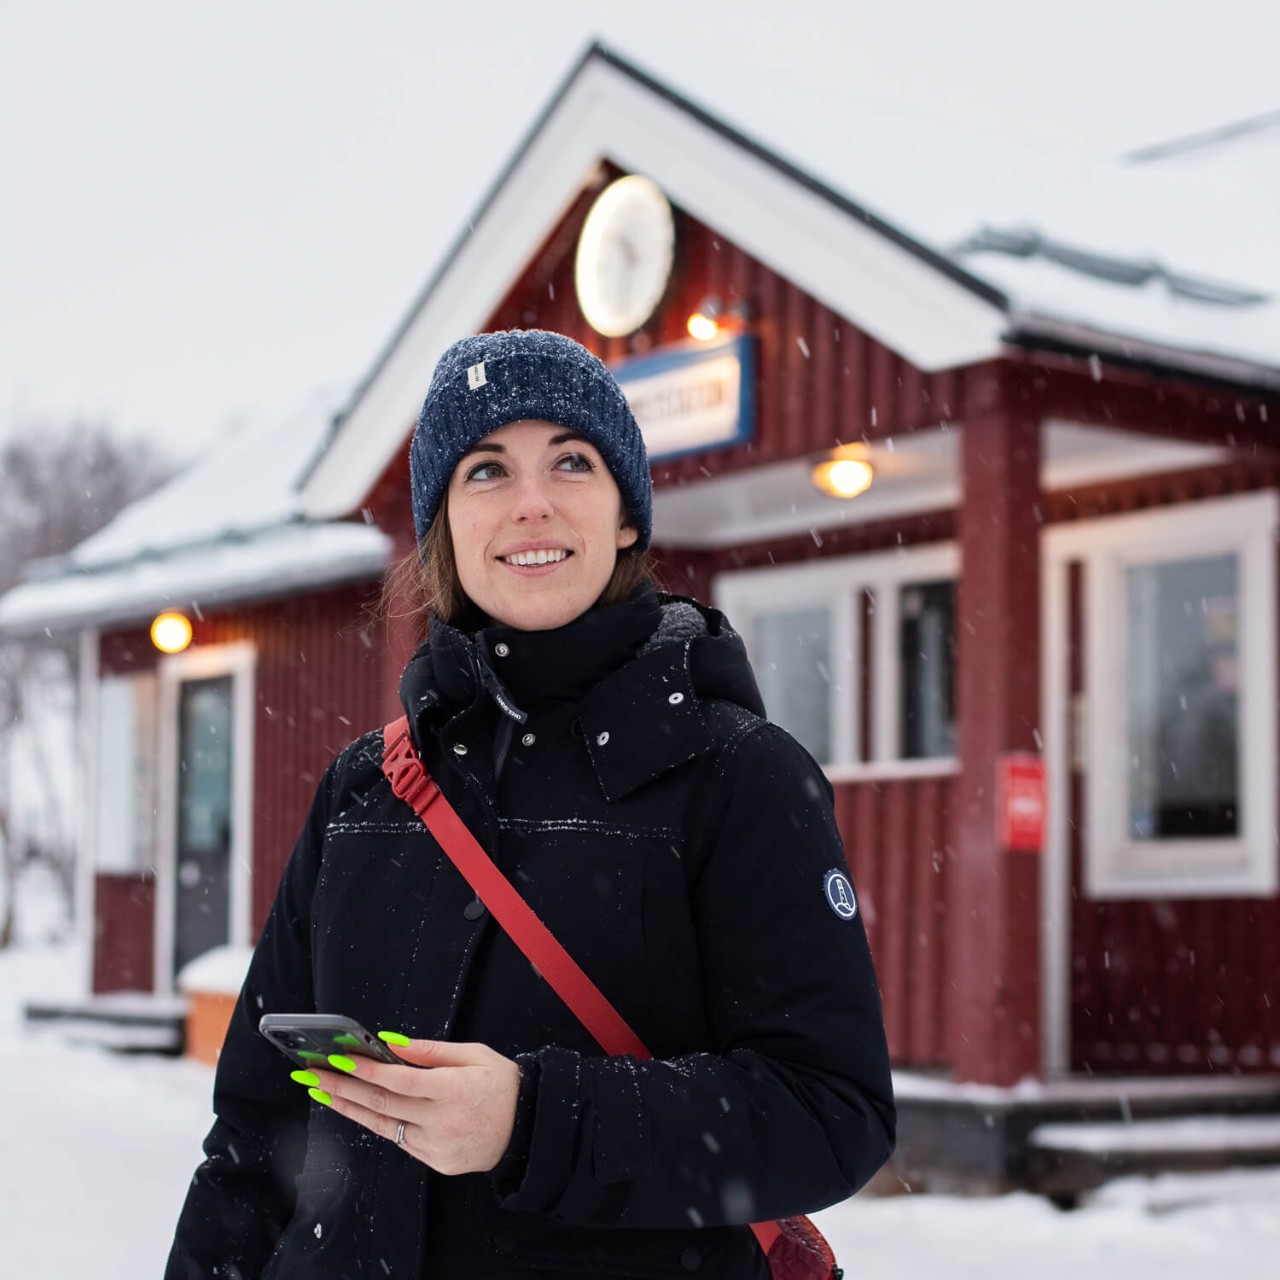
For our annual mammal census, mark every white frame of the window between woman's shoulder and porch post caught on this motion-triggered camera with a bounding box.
[712,543,960,782]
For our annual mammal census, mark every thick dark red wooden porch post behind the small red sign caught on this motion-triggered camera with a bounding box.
[947,394,1043,1084]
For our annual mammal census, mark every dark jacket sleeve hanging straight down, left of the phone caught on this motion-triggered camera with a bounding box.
[165,752,334,1280]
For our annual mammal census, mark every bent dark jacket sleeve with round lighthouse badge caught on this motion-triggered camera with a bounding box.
[498,723,895,1228]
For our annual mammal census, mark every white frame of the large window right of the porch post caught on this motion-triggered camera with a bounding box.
[1046,492,1280,900]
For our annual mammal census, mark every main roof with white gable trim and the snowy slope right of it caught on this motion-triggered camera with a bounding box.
[296,47,1280,517]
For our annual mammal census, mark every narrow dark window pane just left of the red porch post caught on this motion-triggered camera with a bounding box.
[899,581,956,760]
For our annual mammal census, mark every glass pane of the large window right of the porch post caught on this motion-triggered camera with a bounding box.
[1126,556,1240,840]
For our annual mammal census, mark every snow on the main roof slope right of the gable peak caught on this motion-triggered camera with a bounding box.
[645,55,1280,371]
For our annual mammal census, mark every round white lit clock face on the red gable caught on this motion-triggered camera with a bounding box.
[573,174,676,338]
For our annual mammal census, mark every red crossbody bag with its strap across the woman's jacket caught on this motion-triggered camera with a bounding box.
[383,716,844,1280]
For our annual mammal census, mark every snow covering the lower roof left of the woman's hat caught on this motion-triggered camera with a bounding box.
[0,390,392,636]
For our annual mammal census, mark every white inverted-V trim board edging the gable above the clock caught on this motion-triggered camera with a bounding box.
[302,54,1006,518]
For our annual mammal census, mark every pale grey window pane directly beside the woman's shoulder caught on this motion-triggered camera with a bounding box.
[753,607,831,764]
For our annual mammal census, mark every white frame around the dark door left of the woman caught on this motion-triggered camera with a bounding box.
[155,640,257,995]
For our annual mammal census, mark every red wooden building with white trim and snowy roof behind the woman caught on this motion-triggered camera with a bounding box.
[0,49,1280,1182]
